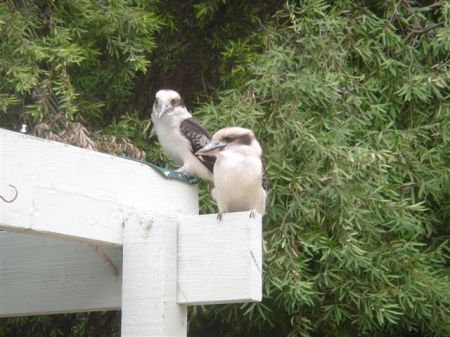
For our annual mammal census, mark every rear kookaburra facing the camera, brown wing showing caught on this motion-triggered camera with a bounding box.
[151,90,215,181]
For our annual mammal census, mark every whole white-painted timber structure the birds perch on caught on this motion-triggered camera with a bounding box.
[0,129,261,337]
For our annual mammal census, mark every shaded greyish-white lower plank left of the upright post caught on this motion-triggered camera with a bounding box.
[0,231,122,317]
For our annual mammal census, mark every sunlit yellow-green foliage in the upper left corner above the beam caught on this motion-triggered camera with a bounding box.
[0,0,162,125]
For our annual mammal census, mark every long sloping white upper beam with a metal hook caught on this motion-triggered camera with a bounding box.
[0,129,198,245]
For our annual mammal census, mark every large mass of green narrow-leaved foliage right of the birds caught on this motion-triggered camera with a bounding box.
[192,0,450,336]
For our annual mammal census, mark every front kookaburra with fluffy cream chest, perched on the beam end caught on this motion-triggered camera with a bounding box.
[197,127,267,219]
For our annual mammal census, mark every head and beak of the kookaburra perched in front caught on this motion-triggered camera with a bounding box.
[196,127,262,157]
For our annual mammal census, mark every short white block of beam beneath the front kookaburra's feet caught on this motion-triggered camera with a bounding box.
[178,212,262,305]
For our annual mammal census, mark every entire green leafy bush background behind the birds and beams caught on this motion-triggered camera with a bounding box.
[0,0,450,337]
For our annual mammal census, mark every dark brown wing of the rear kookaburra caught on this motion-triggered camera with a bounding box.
[180,118,216,172]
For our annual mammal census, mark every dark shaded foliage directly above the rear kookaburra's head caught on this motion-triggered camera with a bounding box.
[147,0,283,103]
